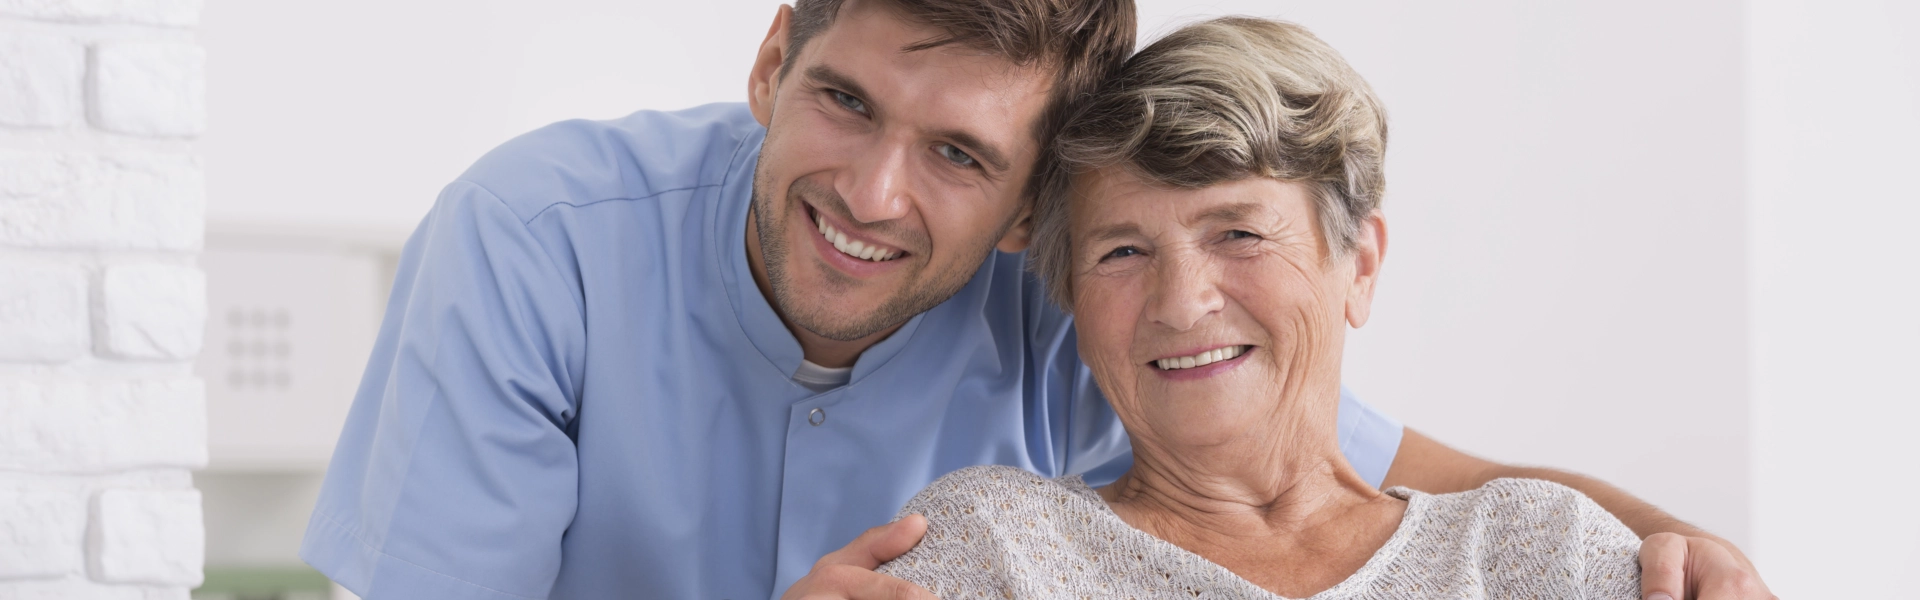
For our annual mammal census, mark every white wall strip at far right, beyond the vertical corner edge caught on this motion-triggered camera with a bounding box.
[1747,0,1920,598]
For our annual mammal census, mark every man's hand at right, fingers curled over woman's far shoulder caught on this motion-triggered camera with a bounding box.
[1640,533,1778,600]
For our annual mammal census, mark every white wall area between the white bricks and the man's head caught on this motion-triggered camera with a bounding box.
[204,0,780,231]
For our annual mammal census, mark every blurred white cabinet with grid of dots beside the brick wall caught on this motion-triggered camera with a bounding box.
[196,225,405,471]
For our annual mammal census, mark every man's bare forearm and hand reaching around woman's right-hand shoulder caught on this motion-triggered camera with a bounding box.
[1382,427,1772,600]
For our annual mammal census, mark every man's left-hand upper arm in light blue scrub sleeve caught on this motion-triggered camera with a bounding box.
[300,181,586,600]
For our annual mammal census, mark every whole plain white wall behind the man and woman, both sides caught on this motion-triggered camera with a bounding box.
[191,0,1920,596]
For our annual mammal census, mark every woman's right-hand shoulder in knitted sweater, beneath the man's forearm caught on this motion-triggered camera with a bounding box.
[1390,479,1640,598]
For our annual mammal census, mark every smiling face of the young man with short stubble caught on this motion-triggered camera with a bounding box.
[753,2,1050,340]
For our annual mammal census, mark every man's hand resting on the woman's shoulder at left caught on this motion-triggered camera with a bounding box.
[780,515,939,600]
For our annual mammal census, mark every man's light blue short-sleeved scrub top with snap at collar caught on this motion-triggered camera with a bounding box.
[301,104,1400,600]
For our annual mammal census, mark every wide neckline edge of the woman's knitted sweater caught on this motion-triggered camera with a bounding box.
[1060,475,1432,600]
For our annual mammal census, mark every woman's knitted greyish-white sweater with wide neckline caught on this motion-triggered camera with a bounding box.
[879,465,1640,600]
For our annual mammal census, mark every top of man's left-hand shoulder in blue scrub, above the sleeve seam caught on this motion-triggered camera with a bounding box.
[459,104,764,219]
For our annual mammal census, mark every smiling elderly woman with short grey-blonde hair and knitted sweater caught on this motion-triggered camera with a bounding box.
[881,17,1640,600]
